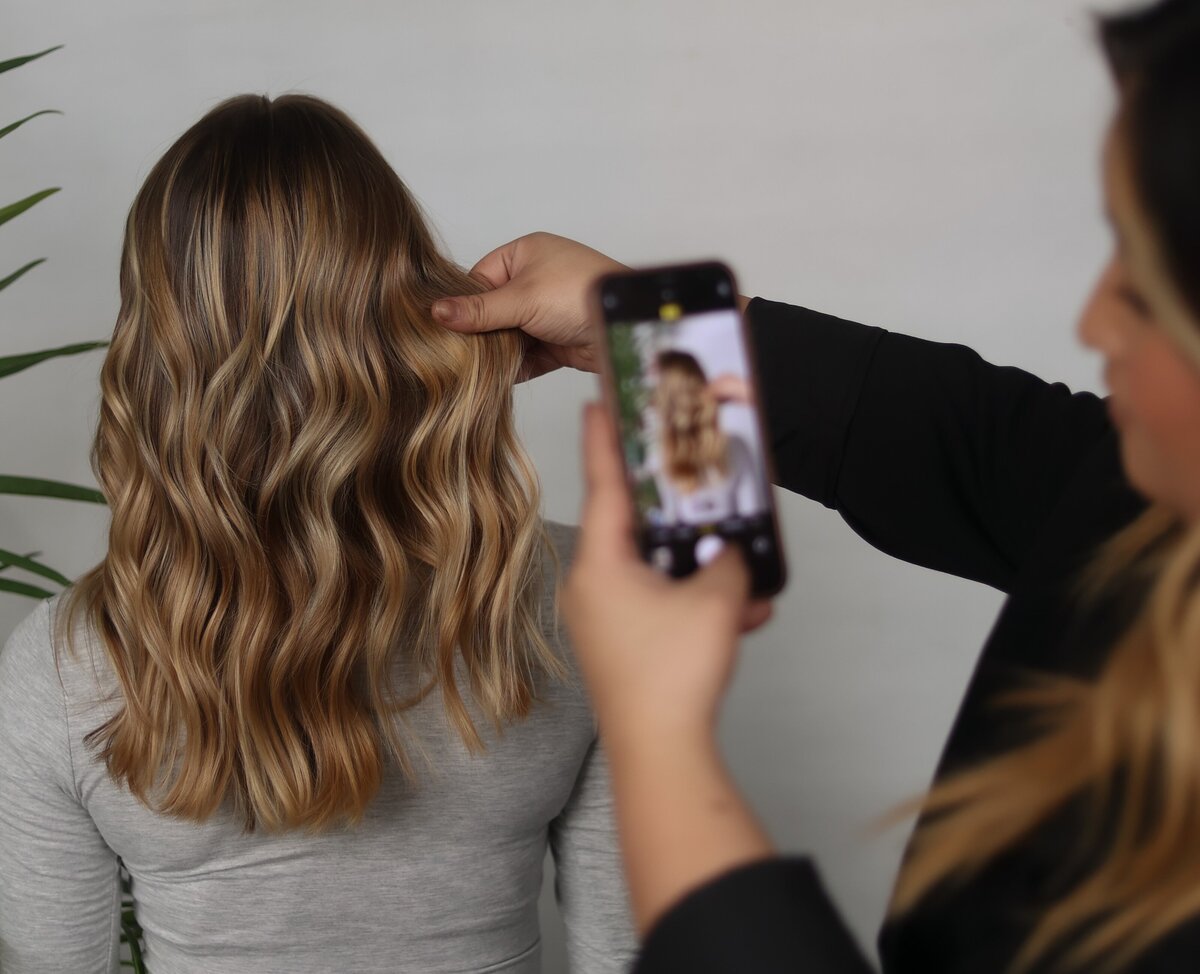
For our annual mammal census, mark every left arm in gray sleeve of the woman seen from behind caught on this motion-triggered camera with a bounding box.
[0,602,120,974]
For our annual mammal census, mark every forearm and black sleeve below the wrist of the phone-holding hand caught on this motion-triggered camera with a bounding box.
[614,728,870,974]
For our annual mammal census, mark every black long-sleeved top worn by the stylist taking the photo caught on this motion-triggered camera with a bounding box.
[636,299,1200,974]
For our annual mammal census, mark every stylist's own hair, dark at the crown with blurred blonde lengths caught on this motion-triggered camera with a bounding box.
[892,0,1200,972]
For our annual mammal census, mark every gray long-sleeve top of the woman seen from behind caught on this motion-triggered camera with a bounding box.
[0,523,635,974]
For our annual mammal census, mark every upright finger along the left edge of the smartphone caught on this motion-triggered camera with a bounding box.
[580,403,640,561]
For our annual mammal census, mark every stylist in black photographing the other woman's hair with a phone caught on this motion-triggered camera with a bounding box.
[434,0,1200,974]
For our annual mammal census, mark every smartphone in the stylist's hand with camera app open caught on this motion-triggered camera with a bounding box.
[592,261,786,596]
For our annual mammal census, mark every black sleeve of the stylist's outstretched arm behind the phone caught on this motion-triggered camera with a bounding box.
[748,299,1110,591]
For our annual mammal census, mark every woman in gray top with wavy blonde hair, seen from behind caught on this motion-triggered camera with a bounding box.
[0,95,631,974]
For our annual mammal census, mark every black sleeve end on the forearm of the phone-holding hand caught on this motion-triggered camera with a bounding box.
[634,858,871,974]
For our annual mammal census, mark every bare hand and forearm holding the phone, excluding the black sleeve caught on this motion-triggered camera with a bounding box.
[563,407,772,931]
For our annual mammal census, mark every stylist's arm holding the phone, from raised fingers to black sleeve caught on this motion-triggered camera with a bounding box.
[563,405,869,974]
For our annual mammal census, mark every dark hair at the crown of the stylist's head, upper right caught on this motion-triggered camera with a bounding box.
[1100,0,1200,318]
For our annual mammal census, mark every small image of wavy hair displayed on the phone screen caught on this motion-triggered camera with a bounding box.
[654,351,730,494]
